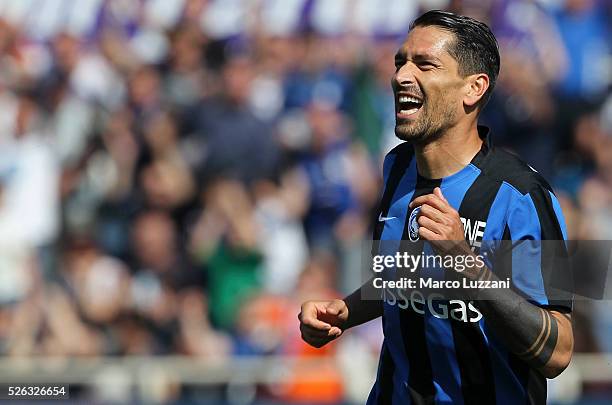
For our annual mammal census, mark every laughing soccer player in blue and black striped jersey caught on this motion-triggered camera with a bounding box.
[299,11,573,405]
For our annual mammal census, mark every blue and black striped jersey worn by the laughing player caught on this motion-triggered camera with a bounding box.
[368,127,572,405]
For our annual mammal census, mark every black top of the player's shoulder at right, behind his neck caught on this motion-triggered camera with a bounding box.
[479,147,552,195]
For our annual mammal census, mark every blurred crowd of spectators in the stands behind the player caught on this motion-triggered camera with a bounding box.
[0,0,612,402]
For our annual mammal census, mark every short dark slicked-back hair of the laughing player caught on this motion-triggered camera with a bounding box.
[410,10,500,108]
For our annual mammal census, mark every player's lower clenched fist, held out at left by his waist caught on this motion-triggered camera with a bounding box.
[298,300,348,348]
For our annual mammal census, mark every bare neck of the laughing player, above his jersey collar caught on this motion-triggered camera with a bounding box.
[414,122,482,179]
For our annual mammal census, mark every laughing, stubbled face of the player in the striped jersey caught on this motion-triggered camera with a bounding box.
[391,26,465,142]
